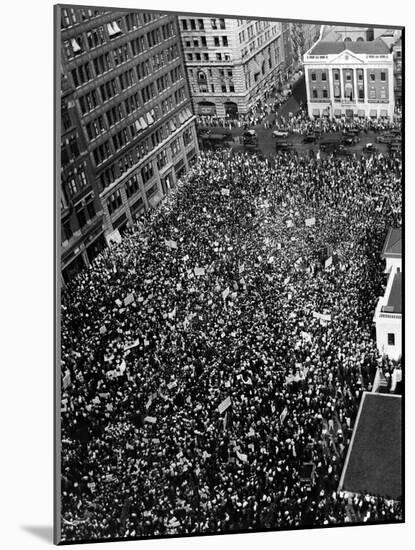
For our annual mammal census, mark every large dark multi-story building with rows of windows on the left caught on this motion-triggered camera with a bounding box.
[60,7,198,280]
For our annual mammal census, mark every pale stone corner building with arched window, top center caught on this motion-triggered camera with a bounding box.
[179,16,284,117]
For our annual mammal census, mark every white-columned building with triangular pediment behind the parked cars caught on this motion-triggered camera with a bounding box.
[304,39,395,118]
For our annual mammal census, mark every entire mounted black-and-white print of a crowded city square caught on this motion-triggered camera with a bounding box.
[55,5,404,544]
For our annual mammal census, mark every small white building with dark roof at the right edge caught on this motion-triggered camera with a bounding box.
[373,228,402,360]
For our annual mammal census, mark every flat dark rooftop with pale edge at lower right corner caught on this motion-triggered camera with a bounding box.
[339,392,402,500]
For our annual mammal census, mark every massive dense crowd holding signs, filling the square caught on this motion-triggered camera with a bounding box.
[61,143,402,540]
